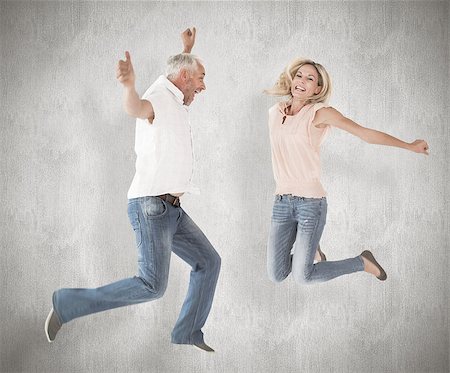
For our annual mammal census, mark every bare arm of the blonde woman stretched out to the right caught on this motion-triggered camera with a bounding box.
[313,107,429,155]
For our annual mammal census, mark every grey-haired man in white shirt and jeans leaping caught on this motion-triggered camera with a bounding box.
[45,28,220,351]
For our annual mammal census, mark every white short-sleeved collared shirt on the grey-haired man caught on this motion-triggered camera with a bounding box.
[128,76,197,198]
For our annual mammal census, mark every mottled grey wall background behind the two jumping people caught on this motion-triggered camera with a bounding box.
[0,1,450,372]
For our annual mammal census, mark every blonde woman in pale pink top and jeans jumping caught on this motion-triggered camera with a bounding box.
[266,59,428,284]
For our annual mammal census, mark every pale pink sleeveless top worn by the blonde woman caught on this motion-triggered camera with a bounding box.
[269,103,329,198]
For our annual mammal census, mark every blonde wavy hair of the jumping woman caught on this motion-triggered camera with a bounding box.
[264,58,331,103]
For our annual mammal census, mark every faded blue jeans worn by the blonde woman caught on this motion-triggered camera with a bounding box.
[267,194,364,284]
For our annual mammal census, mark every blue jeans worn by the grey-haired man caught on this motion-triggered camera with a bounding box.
[53,197,221,344]
